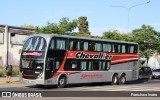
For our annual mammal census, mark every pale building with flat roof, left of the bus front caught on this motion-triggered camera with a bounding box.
[0,25,34,66]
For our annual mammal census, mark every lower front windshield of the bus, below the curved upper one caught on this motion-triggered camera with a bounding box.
[21,57,44,70]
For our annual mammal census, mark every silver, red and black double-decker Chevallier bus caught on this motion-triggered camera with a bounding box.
[20,34,139,88]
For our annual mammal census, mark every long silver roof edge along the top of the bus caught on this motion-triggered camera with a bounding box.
[31,33,138,45]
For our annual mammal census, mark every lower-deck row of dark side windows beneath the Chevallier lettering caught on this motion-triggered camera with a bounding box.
[64,59,111,71]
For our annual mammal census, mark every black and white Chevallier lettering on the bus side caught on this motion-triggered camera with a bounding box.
[76,52,112,60]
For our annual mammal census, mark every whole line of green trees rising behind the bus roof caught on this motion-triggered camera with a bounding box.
[20,16,160,59]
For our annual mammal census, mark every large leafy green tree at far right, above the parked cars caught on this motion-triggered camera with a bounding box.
[132,25,160,57]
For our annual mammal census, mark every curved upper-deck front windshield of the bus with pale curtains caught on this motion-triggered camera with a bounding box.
[23,36,46,51]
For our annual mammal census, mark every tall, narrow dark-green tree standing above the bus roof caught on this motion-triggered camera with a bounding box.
[78,16,90,35]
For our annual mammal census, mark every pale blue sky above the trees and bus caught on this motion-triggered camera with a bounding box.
[0,0,160,36]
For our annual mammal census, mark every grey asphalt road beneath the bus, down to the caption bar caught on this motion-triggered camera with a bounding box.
[0,79,160,91]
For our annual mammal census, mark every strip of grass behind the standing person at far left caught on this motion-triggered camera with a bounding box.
[0,66,19,77]
